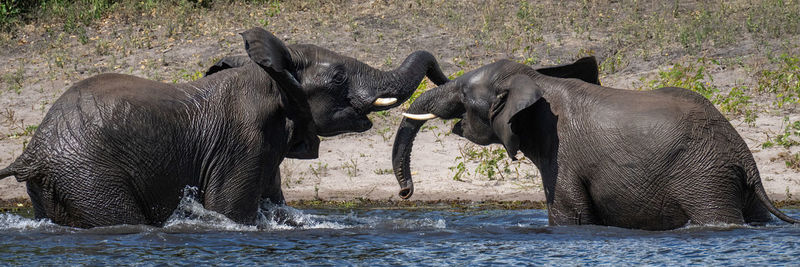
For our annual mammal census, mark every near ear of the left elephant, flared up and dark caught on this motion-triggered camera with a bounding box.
[241,27,319,159]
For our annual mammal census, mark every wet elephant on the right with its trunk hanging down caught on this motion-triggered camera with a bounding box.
[392,57,798,230]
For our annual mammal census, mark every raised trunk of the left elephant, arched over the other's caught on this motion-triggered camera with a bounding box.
[373,51,449,111]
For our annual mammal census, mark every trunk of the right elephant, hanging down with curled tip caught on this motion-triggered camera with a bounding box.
[392,82,464,199]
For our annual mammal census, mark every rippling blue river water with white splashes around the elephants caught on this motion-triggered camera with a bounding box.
[0,201,800,266]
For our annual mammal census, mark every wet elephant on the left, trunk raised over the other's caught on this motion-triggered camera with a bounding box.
[0,28,446,228]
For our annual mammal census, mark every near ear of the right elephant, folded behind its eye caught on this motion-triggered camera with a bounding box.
[489,75,542,160]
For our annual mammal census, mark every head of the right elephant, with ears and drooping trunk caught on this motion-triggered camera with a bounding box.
[392,57,599,198]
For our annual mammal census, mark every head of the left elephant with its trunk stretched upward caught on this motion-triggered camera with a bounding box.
[206,36,448,136]
